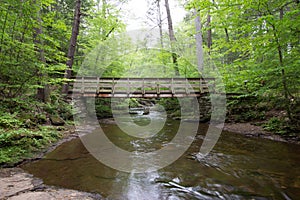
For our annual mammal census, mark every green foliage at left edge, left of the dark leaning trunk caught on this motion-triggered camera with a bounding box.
[0,0,67,98]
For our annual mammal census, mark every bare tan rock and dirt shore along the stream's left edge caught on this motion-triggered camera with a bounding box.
[0,126,103,200]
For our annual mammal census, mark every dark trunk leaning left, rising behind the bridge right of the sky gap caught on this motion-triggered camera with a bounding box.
[165,0,180,76]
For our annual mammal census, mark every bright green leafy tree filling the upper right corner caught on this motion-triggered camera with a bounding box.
[187,0,300,120]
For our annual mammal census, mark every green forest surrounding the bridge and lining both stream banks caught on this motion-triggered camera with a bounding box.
[0,0,300,165]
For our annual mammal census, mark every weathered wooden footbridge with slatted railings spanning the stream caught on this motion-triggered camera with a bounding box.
[69,77,215,98]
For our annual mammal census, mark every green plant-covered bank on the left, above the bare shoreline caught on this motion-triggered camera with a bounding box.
[0,125,78,168]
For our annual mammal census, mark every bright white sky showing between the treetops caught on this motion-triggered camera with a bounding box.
[122,0,185,31]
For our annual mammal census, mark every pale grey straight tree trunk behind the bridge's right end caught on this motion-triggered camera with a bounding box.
[195,11,204,72]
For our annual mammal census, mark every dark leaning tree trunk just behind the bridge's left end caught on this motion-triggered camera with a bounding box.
[62,0,81,94]
